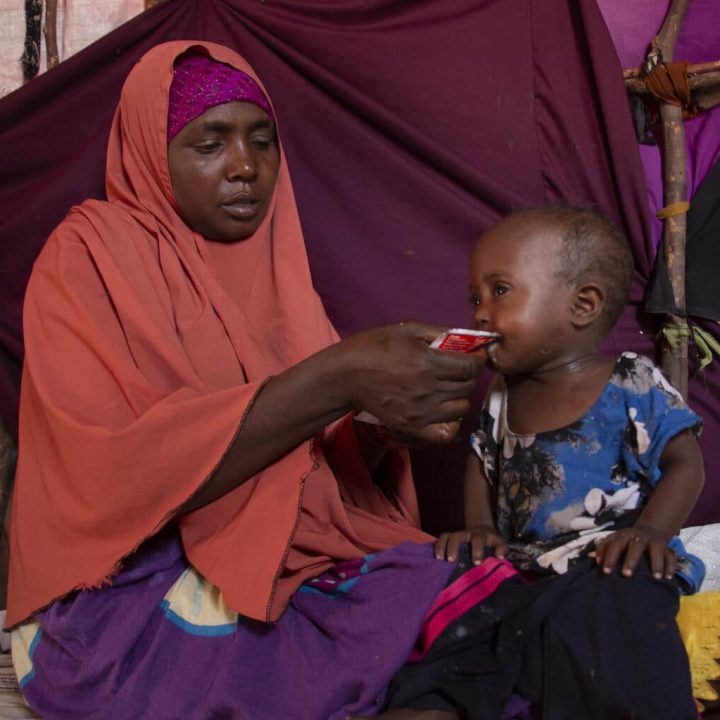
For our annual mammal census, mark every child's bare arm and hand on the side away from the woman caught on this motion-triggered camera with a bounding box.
[597,430,705,578]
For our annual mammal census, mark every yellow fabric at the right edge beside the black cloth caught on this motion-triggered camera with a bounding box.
[677,592,720,701]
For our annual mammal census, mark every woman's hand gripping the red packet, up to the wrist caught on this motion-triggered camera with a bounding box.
[335,322,485,443]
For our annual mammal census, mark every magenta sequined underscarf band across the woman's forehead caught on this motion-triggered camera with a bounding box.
[168,54,275,143]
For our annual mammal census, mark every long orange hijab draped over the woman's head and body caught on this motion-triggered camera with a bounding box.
[7,41,428,626]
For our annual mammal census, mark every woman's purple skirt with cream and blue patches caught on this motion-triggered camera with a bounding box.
[13,534,462,720]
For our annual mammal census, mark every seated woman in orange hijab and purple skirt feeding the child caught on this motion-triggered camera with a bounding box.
[7,42,481,720]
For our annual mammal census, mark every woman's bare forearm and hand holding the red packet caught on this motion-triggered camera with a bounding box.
[182,323,484,512]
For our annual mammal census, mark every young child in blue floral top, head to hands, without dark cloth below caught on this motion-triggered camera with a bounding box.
[436,207,704,592]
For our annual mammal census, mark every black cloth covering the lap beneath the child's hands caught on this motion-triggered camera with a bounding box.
[388,560,696,720]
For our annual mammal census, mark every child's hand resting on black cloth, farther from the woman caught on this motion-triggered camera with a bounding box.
[595,526,677,580]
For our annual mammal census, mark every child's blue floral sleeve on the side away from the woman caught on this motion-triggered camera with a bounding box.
[625,356,702,485]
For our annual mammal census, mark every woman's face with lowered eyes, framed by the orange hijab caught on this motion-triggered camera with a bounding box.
[168,102,280,243]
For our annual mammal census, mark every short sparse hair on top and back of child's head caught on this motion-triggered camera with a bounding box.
[512,205,633,332]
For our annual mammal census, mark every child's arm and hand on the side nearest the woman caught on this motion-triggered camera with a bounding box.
[435,452,507,565]
